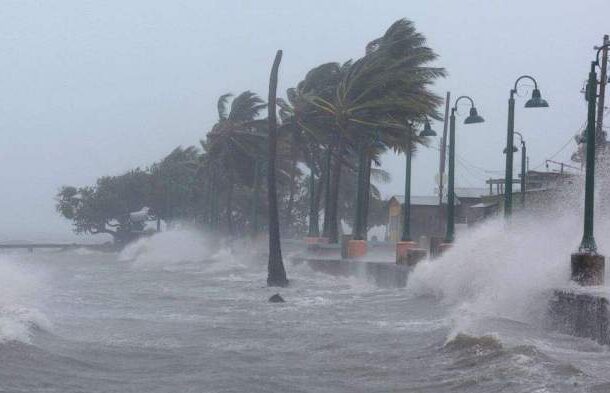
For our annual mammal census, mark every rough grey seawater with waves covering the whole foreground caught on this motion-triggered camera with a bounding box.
[0,223,610,393]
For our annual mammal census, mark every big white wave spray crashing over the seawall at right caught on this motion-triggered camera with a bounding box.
[408,214,580,335]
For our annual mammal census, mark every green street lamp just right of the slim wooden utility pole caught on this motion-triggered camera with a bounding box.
[445,96,484,243]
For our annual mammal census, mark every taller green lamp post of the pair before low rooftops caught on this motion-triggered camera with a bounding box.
[504,75,549,218]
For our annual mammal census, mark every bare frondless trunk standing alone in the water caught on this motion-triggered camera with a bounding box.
[267,50,288,287]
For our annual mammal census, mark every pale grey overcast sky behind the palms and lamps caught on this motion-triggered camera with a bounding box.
[0,0,610,239]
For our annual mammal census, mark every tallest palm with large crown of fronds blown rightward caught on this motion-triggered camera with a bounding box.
[309,19,445,242]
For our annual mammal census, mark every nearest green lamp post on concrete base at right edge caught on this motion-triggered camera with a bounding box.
[571,44,610,285]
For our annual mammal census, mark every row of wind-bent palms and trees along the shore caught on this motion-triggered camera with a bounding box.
[56,19,445,243]
